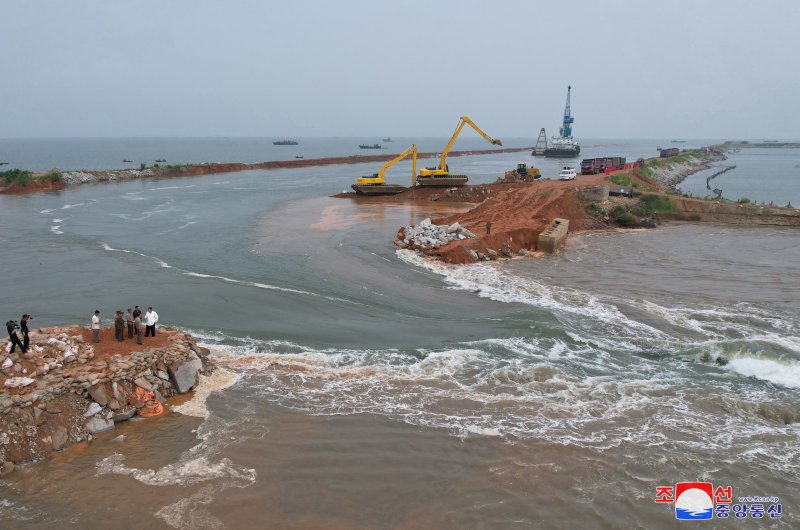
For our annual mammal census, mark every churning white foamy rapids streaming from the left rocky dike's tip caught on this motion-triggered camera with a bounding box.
[186,331,800,470]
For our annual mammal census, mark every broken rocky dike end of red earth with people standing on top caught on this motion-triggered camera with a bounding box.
[0,326,215,475]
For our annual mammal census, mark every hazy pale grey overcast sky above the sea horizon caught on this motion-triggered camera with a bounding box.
[0,0,800,138]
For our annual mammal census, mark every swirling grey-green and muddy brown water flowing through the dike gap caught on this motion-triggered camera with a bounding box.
[0,140,800,528]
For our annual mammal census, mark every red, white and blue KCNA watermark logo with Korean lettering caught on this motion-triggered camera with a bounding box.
[655,482,783,521]
